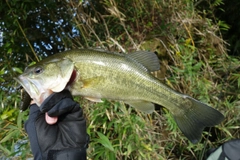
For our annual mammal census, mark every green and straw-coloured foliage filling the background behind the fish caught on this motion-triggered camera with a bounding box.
[0,0,240,160]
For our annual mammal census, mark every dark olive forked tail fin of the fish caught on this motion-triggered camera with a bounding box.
[173,96,224,143]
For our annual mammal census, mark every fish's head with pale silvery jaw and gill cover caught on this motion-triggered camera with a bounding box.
[14,58,74,106]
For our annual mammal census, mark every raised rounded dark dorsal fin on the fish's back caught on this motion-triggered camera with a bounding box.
[126,51,160,72]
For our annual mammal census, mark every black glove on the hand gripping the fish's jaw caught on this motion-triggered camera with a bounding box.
[25,90,89,160]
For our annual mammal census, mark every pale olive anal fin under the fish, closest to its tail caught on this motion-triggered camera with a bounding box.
[124,101,155,113]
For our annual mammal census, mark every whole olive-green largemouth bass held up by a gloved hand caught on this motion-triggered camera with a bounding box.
[16,49,224,143]
